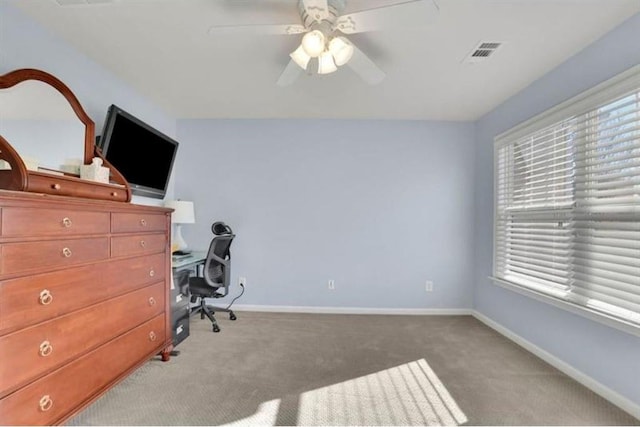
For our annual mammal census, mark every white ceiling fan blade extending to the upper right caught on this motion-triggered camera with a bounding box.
[333,0,439,34]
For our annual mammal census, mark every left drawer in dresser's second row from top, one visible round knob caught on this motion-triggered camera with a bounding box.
[0,236,109,274]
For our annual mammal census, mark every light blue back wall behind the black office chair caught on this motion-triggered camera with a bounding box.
[175,120,474,308]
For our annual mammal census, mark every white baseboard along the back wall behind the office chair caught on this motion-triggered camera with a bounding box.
[233,304,473,316]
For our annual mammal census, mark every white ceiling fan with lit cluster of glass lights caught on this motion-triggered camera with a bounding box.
[209,0,438,86]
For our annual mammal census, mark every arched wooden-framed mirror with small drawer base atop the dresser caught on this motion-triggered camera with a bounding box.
[0,69,131,202]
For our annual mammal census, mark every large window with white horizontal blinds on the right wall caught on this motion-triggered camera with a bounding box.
[494,67,640,328]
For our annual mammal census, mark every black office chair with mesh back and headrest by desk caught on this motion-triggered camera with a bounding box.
[189,222,239,332]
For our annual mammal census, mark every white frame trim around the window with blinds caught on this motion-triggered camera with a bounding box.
[489,65,640,336]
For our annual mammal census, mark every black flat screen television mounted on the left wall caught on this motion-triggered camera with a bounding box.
[97,105,178,199]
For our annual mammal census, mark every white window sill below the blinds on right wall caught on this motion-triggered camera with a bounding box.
[489,276,640,337]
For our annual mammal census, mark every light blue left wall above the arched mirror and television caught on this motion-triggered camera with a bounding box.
[0,1,176,204]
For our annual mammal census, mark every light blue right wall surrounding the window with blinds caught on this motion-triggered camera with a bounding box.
[475,15,640,405]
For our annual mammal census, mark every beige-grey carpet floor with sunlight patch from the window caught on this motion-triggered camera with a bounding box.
[69,312,640,426]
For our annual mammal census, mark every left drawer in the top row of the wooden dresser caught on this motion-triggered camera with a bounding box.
[2,207,109,237]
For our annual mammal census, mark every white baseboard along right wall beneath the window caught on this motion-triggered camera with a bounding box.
[471,310,640,419]
